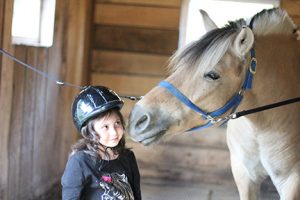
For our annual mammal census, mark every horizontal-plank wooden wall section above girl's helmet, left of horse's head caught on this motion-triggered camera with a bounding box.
[90,0,181,119]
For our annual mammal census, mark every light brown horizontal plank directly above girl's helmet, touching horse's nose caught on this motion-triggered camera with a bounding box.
[91,73,164,96]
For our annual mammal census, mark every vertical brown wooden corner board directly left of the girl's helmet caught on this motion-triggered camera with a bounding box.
[58,0,94,175]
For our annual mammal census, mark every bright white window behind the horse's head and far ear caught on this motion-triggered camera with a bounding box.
[179,0,279,46]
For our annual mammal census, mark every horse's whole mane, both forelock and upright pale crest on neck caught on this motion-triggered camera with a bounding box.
[168,8,296,78]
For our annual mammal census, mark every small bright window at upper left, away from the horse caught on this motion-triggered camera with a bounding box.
[12,0,55,47]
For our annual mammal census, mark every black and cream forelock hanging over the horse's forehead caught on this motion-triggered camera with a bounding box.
[169,19,246,78]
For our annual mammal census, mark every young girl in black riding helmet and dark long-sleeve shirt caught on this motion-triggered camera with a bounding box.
[61,86,141,200]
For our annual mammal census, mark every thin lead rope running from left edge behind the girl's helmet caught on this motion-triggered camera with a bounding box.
[0,48,142,101]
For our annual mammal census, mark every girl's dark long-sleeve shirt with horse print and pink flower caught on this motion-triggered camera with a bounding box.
[61,150,142,200]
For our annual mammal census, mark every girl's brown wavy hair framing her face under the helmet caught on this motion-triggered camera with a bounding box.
[70,109,127,159]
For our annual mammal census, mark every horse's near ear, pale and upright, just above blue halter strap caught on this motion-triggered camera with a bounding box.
[233,27,254,57]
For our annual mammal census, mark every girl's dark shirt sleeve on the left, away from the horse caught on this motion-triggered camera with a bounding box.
[61,155,84,200]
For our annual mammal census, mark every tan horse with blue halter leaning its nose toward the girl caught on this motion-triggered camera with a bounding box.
[127,8,300,200]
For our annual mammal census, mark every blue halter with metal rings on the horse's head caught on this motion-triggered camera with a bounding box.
[159,48,257,131]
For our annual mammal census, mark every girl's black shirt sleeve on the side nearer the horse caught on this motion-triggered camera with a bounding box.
[130,152,142,200]
